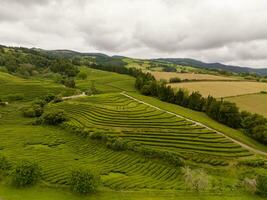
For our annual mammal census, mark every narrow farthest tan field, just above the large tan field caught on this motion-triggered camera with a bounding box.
[151,72,241,81]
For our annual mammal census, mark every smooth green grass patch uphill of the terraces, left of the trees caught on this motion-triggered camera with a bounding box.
[76,67,136,93]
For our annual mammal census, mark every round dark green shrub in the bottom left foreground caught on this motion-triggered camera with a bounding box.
[12,161,41,187]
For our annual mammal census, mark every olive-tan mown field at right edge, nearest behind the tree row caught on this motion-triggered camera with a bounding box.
[226,94,267,117]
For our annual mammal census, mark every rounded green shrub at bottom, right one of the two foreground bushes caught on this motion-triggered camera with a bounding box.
[70,169,99,194]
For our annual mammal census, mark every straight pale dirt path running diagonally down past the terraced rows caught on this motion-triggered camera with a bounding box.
[121,92,267,156]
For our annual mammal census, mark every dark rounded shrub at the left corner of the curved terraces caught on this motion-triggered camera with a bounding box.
[41,110,67,125]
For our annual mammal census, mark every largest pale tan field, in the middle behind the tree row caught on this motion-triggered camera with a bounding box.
[169,81,267,98]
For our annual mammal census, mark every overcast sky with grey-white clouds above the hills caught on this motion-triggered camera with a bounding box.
[0,0,267,68]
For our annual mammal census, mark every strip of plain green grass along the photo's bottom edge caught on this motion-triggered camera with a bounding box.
[0,185,264,200]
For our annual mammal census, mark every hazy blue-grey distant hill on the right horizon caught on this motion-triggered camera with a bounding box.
[154,58,267,76]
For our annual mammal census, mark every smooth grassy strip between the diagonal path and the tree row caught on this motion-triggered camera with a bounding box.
[127,93,267,152]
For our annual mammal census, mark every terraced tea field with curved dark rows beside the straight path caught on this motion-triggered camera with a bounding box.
[51,94,254,166]
